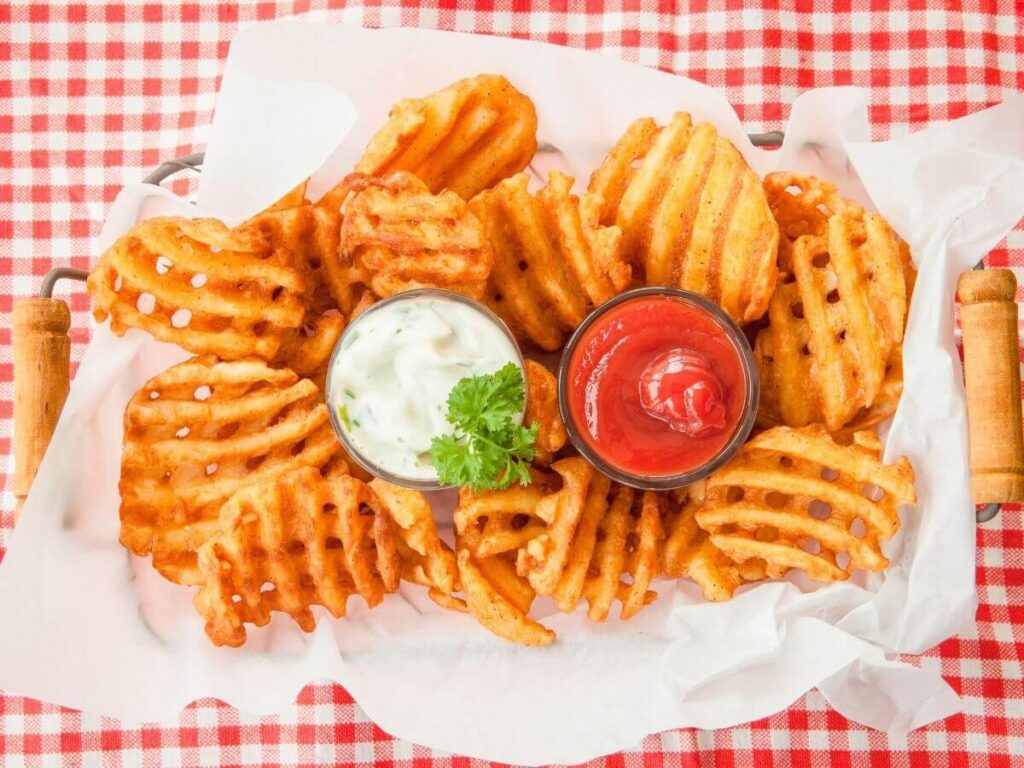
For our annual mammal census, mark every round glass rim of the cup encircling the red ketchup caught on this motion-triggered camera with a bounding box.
[558,286,761,490]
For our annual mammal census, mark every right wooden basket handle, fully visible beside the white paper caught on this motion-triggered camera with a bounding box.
[956,269,1024,504]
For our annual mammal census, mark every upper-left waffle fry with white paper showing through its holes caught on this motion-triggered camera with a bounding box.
[88,217,306,359]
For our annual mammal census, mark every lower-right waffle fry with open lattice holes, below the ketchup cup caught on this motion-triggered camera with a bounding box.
[695,426,916,582]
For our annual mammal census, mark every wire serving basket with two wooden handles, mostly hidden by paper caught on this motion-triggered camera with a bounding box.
[13,144,1024,536]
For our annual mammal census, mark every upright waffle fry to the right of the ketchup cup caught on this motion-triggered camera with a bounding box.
[755,174,912,432]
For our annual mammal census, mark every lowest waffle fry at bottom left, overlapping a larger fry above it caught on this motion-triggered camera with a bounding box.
[195,467,398,647]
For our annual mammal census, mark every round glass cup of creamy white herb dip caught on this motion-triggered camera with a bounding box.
[327,288,525,489]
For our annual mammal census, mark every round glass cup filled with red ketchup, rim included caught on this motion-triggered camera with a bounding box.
[558,287,760,489]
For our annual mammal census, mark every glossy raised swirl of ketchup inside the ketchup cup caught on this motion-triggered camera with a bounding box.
[640,347,725,437]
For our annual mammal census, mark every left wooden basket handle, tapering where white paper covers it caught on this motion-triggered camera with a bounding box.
[13,297,71,520]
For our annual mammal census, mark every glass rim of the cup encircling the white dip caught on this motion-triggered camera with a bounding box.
[324,288,526,490]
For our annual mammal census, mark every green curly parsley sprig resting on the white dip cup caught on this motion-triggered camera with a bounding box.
[430,362,538,490]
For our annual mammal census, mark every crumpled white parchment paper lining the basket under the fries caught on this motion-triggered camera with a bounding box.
[0,23,1024,764]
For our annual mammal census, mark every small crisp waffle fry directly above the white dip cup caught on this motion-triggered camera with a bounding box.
[340,172,492,301]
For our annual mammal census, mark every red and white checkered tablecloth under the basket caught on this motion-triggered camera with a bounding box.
[0,0,1024,768]
